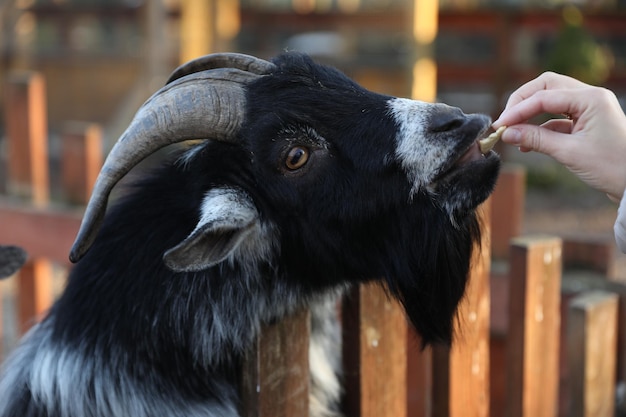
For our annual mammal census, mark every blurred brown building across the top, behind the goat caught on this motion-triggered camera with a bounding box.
[0,0,626,136]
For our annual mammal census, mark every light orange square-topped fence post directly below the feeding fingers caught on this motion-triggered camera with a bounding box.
[507,237,562,417]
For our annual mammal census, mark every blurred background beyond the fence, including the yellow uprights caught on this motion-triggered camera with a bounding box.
[0,0,626,260]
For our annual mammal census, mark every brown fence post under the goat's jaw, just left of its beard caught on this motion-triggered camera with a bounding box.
[342,283,408,417]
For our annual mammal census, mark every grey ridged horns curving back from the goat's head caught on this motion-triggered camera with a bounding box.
[70,54,274,262]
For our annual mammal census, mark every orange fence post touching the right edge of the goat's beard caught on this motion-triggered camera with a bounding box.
[433,200,491,417]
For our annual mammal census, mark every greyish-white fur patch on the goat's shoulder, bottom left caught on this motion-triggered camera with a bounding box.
[0,322,238,417]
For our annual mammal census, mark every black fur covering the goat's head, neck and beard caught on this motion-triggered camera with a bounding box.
[0,54,498,417]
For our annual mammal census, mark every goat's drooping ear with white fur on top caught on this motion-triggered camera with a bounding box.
[163,189,259,272]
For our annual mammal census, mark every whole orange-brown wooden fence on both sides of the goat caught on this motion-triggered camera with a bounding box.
[0,73,626,417]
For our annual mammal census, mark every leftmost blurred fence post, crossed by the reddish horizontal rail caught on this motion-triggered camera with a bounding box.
[6,72,52,332]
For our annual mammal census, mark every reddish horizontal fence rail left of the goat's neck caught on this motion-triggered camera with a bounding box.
[0,200,82,265]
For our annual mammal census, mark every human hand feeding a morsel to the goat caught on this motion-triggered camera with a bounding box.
[493,72,626,200]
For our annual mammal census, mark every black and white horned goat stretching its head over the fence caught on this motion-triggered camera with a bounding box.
[0,52,500,417]
